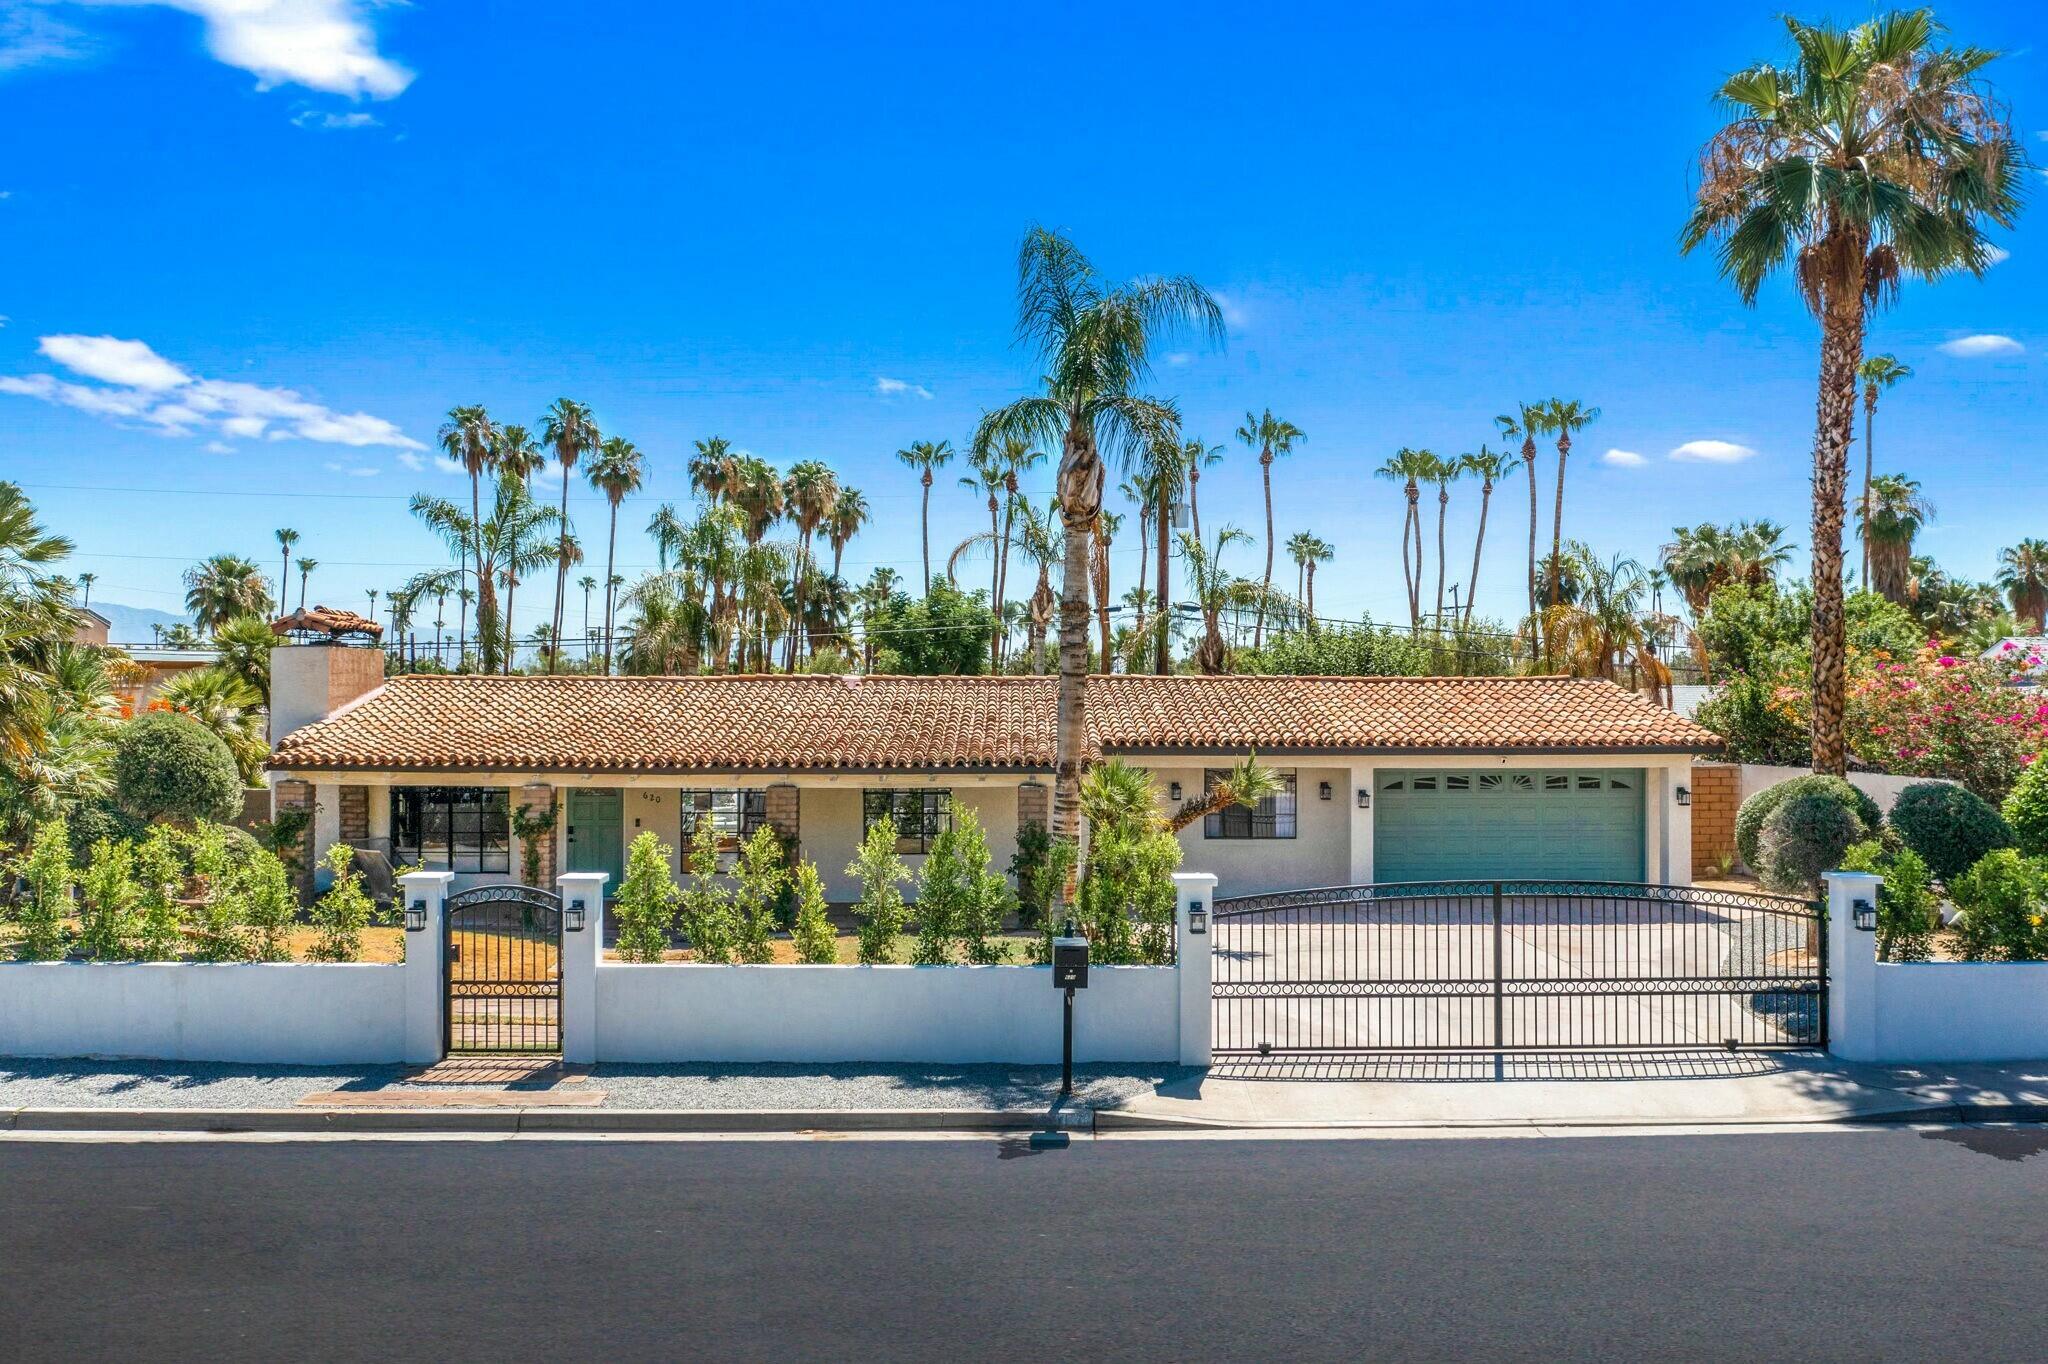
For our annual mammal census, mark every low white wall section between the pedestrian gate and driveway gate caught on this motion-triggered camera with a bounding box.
[596,963,1180,1065]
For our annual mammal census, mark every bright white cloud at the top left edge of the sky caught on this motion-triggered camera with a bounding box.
[80,0,412,100]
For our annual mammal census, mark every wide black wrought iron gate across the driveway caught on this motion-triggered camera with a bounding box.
[1212,881,1827,1055]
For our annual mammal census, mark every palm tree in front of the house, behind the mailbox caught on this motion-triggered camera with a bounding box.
[975,227,1223,842]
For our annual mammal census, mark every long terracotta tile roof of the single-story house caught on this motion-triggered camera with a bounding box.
[270,676,1716,772]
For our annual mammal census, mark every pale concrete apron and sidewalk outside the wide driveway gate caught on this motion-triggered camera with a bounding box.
[1096,1053,2048,1131]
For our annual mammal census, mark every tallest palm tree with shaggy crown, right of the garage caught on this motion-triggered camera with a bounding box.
[1679,10,2028,776]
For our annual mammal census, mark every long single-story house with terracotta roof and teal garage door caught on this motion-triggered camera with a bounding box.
[270,645,1716,901]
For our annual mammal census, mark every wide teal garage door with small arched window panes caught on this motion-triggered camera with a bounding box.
[1372,768,1642,883]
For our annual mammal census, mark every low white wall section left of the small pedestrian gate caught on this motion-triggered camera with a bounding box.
[0,963,406,1065]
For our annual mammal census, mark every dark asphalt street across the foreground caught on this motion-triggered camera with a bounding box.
[0,1128,2048,1362]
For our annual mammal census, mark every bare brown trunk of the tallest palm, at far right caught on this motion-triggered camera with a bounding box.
[1812,303,1864,776]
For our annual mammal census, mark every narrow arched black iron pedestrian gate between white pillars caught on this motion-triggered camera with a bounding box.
[442,885,561,1055]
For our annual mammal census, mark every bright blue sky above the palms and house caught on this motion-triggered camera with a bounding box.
[0,0,2048,638]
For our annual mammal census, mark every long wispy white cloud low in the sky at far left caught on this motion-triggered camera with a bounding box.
[0,336,426,451]
